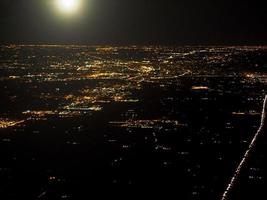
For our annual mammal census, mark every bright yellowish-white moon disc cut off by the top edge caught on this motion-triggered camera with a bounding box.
[57,0,81,13]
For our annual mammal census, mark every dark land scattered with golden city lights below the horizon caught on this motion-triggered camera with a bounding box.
[0,46,267,200]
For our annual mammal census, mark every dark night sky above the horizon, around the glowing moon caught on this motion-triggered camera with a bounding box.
[0,0,267,45]
